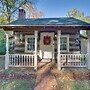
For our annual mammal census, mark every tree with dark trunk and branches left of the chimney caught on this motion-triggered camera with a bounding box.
[0,0,36,23]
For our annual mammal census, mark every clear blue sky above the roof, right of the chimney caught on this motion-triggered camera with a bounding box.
[36,0,90,18]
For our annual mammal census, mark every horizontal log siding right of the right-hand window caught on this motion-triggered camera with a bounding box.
[61,30,80,53]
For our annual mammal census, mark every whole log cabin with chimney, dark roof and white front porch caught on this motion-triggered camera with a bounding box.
[0,9,90,70]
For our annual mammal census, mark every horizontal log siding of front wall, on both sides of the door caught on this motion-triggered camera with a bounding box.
[10,30,80,54]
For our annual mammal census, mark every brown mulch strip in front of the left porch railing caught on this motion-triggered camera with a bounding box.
[0,69,36,82]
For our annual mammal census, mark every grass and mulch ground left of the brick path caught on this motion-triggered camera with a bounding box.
[0,56,36,90]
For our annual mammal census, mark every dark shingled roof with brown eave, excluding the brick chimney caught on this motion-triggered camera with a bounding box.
[0,17,90,31]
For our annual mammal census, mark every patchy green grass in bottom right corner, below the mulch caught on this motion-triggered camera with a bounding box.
[58,79,90,90]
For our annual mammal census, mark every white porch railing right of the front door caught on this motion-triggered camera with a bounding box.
[60,54,87,67]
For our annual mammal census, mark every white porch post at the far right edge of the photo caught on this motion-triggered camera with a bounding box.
[87,30,90,69]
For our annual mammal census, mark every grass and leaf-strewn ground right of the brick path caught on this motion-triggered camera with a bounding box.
[51,68,90,90]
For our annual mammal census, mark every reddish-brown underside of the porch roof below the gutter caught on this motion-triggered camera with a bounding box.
[0,25,90,32]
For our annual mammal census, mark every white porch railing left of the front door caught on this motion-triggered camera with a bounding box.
[9,54,35,67]
